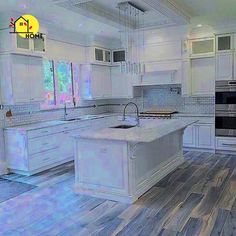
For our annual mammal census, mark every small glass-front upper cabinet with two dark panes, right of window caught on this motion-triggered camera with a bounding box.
[86,47,111,65]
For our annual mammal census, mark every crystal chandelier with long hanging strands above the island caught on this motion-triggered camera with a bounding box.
[117,2,145,75]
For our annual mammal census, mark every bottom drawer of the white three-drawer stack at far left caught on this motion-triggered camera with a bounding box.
[29,148,60,170]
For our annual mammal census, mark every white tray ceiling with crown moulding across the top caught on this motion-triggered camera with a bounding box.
[0,0,236,38]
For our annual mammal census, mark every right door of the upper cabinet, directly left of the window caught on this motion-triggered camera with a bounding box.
[28,57,44,102]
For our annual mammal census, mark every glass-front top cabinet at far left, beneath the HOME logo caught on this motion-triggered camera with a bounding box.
[0,30,46,55]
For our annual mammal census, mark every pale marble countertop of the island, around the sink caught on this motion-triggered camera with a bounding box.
[73,119,198,143]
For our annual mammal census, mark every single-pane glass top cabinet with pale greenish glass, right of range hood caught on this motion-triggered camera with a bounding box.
[189,38,215,58]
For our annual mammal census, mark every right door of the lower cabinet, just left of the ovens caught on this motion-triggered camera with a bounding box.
[195,124,215,149]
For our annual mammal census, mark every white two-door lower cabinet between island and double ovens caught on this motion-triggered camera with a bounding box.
[183,123,215,149]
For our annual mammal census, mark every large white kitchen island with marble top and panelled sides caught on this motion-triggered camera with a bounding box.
[74,119,196,203]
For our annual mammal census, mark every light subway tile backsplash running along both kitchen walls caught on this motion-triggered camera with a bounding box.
[0,86,215,127]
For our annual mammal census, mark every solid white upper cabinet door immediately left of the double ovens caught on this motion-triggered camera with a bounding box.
[191,57,215,96]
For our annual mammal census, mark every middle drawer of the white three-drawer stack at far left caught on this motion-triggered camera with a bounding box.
[28,134,60,155]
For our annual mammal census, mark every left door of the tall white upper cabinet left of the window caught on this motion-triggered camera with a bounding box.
[11,55,30,103]
